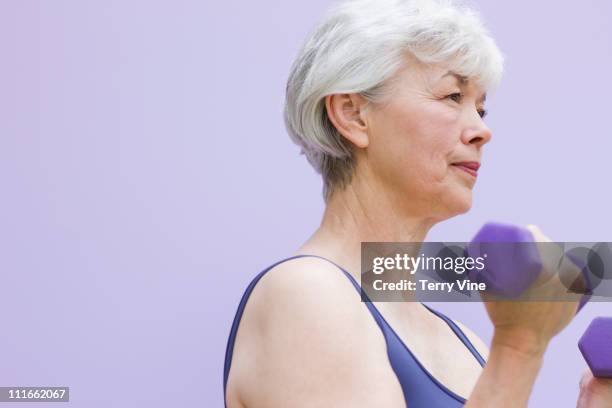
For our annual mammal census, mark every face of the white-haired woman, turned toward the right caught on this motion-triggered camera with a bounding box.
[358,58,491,220]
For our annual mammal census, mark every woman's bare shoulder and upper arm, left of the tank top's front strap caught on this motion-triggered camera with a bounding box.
[228,257,404,407]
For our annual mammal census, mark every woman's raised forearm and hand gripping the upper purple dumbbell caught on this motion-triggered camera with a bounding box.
[466,226,580,408]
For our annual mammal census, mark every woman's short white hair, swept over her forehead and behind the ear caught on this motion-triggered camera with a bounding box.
[284,0,504,201]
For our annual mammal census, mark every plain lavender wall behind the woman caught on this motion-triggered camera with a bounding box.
[0,0,612,408]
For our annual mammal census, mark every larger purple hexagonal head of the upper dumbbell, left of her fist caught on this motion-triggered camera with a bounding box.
[467,222,542,298]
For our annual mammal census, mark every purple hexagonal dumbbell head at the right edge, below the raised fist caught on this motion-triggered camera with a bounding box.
[578,317,612,378]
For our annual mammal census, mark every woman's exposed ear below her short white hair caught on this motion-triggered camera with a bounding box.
[325,93,369,148]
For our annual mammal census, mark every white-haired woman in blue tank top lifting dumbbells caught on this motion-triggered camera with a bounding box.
[224,0,612,408]
